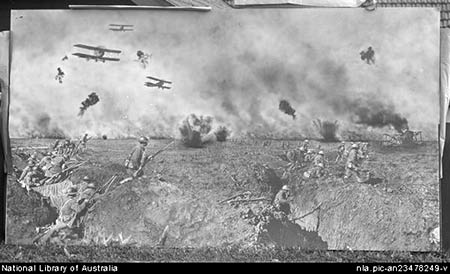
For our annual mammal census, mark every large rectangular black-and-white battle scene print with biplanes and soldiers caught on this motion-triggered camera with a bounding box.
[7,8,439,251]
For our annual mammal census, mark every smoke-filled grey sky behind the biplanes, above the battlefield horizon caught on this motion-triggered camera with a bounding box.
[10,8,439,140]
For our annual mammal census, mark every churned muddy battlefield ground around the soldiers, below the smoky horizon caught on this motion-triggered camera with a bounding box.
[7,139,439,251]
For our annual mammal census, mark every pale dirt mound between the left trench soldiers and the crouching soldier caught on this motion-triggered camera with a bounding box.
[82,180,253,247]
